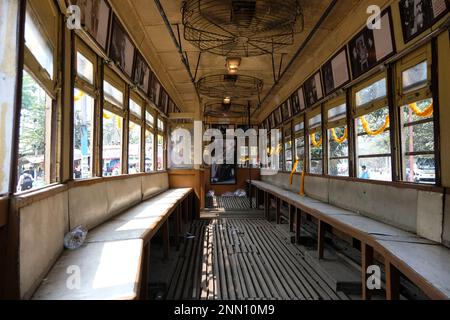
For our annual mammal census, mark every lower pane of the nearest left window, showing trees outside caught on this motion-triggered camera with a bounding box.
[17,71,52,192]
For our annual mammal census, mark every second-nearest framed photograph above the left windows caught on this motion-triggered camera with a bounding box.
[109,16,134,78]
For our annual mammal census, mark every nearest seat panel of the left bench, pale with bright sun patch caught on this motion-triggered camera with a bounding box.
[33,240,143,300]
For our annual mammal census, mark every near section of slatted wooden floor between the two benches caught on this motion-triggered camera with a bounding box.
[166,214,348,300]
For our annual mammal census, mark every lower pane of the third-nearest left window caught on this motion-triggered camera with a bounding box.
[103,110,123,177]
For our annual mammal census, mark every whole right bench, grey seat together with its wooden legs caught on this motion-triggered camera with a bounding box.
[251,181,450,299]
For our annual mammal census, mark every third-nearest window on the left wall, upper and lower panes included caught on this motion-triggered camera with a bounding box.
[102,68,125,177]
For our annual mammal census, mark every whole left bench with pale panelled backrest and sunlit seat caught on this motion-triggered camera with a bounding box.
[11,172,195,300]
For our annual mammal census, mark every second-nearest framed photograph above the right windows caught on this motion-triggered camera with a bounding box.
[348,10,395,79]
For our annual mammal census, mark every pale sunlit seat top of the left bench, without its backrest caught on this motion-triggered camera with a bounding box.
[33,188,192,300]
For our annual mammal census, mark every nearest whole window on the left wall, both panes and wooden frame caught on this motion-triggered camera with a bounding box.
[16,0,59,192]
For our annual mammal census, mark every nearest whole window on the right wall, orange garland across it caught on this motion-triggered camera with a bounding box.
[397,45,437,184]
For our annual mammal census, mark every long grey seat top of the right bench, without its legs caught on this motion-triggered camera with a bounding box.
[251,181,450,299]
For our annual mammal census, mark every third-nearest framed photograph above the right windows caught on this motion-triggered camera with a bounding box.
[322,48,350,95]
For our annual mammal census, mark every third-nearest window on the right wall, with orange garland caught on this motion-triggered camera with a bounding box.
[324,96,349,177]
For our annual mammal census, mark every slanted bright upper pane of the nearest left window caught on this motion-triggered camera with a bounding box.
[25,10,53,79]
